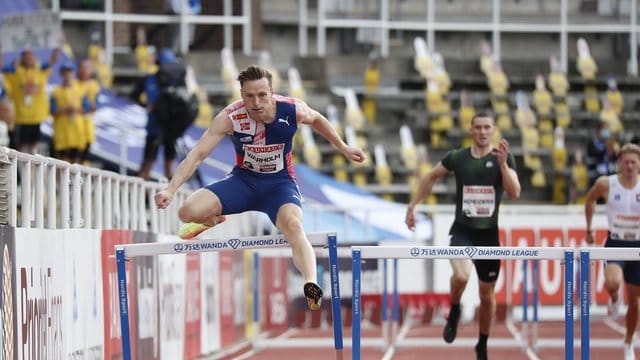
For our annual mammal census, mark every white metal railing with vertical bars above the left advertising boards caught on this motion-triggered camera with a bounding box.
[0,148,189,233]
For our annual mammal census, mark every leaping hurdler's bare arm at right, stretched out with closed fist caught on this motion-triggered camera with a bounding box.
[296,99,365,162]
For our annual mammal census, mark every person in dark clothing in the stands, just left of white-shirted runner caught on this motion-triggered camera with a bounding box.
[585,121,618,186]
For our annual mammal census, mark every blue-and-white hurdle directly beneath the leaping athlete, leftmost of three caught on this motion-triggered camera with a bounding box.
[115,232,343,360]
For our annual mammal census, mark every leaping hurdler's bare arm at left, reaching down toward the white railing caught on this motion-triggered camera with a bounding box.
[156,110,233,208]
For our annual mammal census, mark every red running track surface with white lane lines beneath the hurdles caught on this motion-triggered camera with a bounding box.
[229,319,640,360]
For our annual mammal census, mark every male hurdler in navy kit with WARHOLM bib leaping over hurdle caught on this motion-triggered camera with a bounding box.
[155,66,365,310]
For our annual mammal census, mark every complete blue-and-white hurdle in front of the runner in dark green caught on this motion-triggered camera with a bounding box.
[351,246,575,360]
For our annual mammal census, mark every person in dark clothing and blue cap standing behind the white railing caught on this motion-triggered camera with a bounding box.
[131,49,178,180]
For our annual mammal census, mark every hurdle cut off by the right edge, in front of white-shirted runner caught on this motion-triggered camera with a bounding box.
[580,247,640,360]
